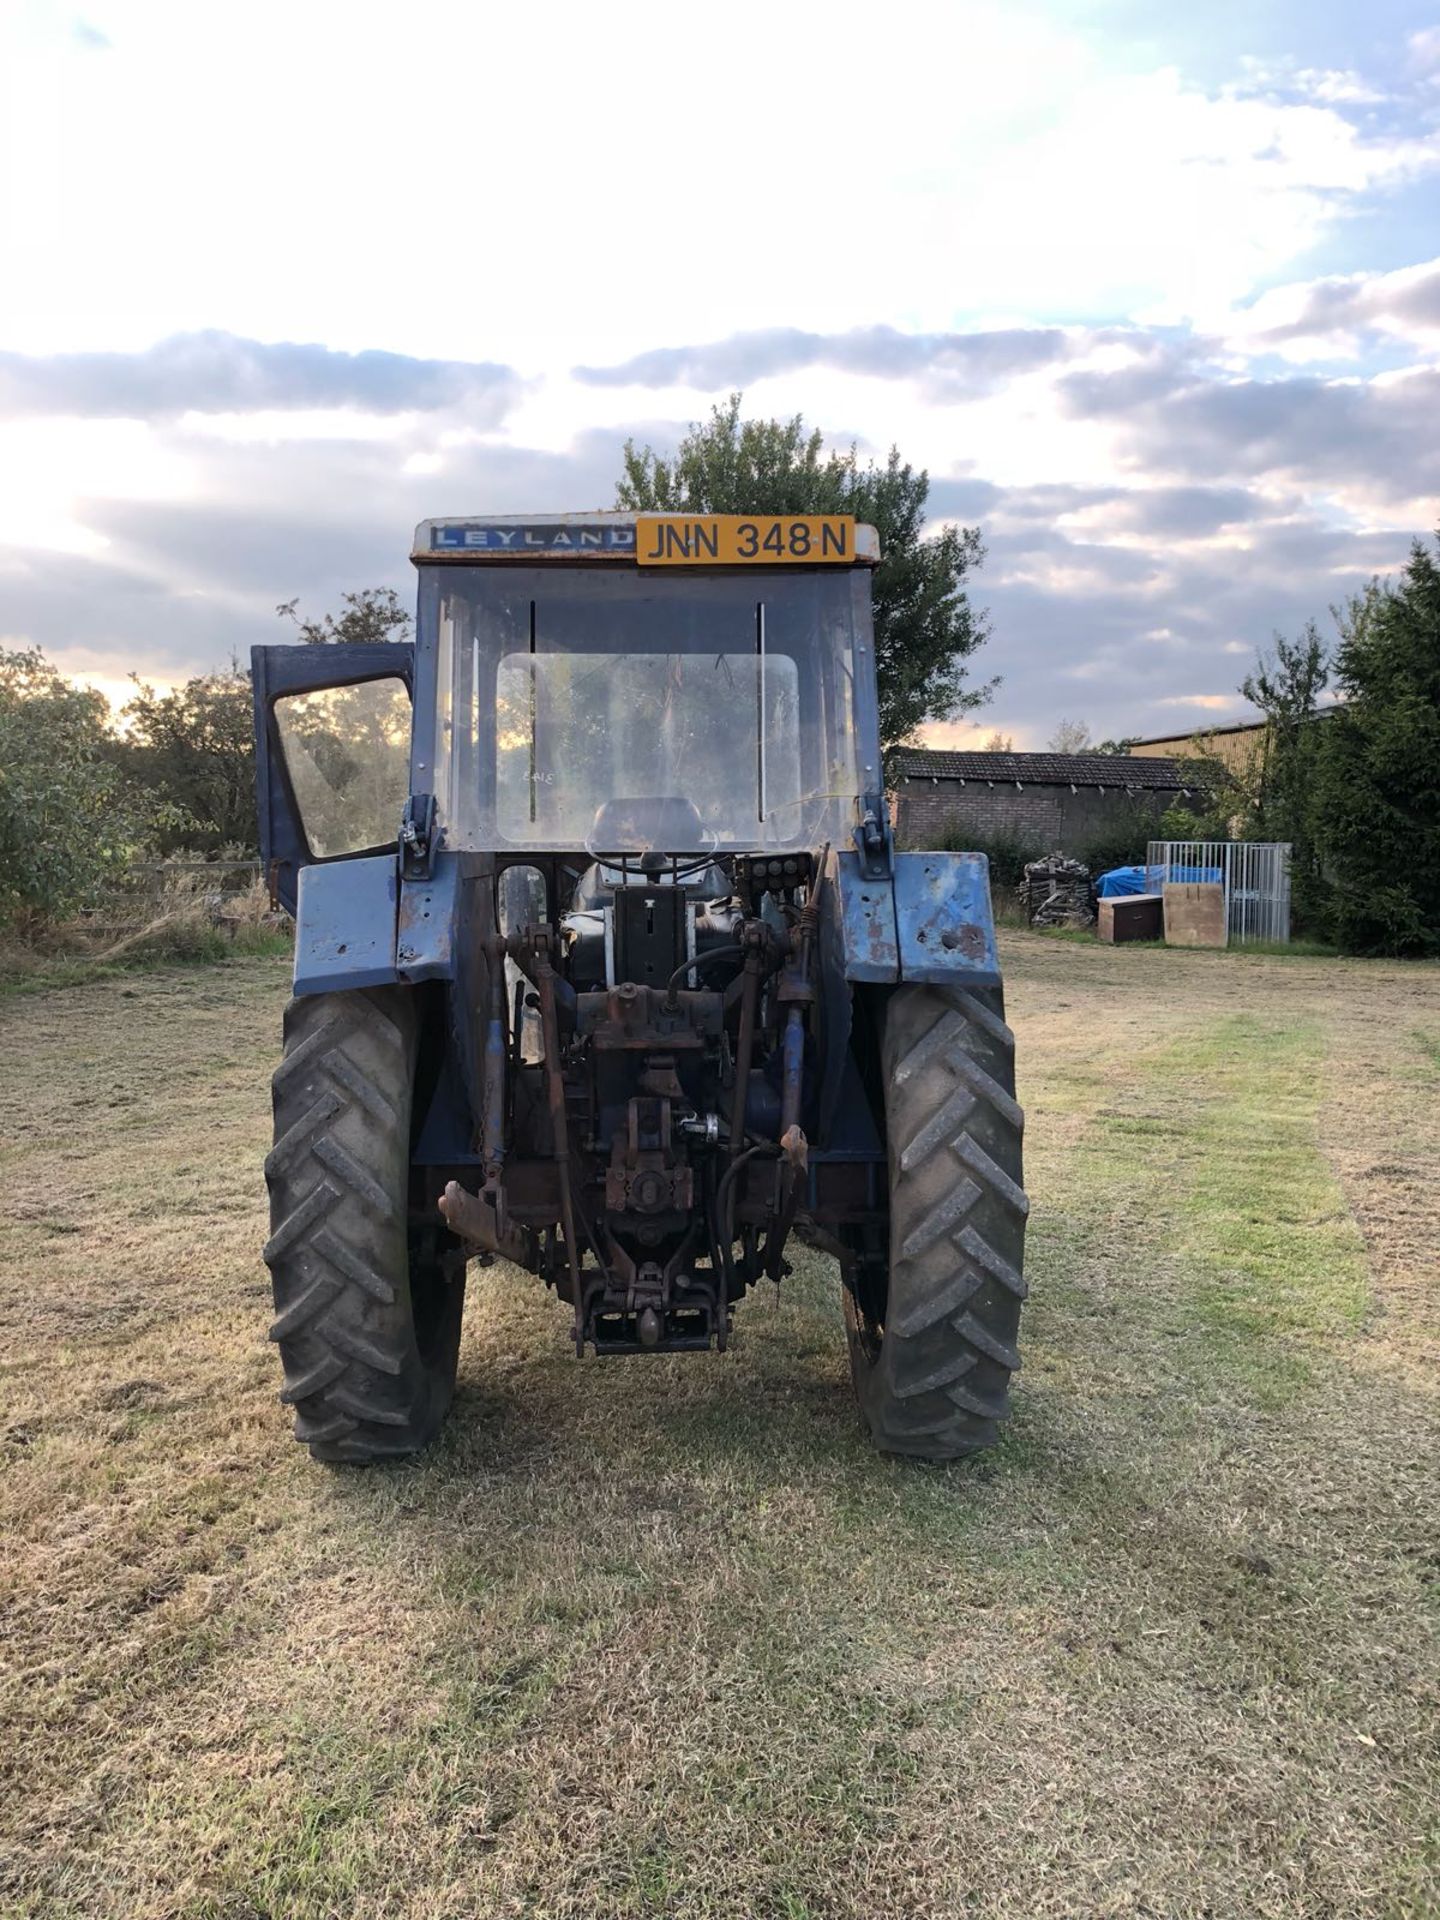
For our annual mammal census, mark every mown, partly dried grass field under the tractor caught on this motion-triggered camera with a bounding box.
[0,935,1440,1920]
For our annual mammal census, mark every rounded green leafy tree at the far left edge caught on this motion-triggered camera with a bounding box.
[0,649,142,929]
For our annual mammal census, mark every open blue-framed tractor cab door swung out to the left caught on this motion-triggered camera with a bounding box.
[250,641,415,914]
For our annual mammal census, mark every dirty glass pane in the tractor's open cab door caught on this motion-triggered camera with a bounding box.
[275,678,411,860]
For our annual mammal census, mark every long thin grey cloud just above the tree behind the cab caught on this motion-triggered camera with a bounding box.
[574,326,1069,397]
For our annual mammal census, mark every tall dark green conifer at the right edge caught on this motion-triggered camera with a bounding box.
[1313,536,1440,954]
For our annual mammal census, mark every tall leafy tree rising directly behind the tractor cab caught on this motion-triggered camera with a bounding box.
[614,394,998,747]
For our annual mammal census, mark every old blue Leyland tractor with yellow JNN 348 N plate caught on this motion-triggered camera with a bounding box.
[253,513,1025,1461]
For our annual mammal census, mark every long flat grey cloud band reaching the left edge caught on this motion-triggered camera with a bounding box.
[0,332,520,424]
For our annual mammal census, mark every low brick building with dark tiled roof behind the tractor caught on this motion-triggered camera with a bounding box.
[891,747,1208,849]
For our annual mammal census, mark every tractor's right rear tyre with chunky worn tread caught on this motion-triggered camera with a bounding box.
[845,987,1029,1459]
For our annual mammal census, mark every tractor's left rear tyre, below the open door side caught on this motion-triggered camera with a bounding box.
[265,987,465,1461]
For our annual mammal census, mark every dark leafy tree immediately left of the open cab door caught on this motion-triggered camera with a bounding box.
[111,660,255,852]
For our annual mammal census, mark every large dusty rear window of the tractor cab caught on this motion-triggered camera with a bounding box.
[436,568,866,854]
